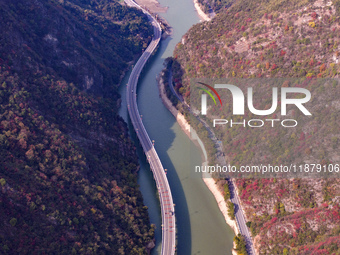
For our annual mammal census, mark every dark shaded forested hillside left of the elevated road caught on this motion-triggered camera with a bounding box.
[0,0,154,254]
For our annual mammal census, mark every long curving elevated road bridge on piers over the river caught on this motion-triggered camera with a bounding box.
[124,0,176,255]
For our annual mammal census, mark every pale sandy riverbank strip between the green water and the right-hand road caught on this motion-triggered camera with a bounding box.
[157,71,239,255]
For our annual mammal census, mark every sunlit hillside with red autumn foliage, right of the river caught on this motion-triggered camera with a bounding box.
[172,0,340,254]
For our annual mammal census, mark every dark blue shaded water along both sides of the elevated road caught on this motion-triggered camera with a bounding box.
[119,36,192,255]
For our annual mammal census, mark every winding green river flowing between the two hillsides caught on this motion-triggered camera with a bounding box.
[119,0,234,255]
